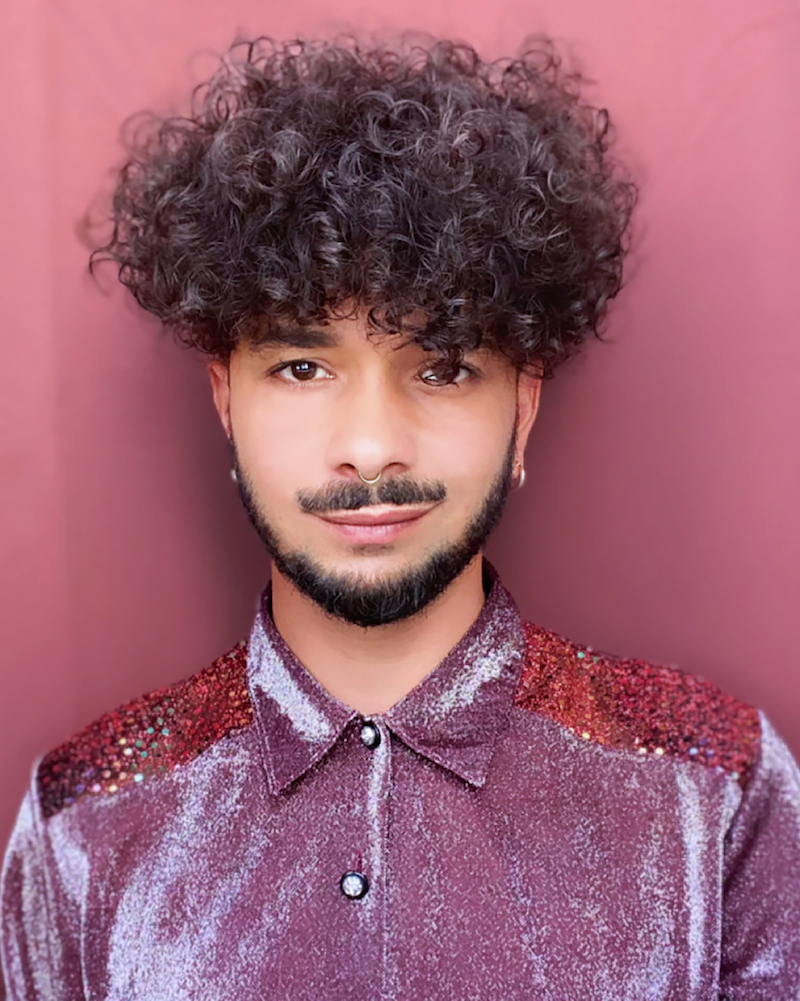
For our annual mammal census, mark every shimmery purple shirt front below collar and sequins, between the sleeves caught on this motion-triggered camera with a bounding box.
[84,733,722,1001]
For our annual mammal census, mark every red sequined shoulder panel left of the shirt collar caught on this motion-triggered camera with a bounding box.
[37,643,252,817]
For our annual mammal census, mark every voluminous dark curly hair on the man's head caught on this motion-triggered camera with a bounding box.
[92,37,636,375]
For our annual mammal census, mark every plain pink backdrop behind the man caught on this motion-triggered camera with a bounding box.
[0,0,800,852]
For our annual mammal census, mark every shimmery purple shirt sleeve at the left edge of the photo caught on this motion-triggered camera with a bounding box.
[0,769,84,1001]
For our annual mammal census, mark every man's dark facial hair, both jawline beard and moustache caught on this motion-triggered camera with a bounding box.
[233,436,517,628]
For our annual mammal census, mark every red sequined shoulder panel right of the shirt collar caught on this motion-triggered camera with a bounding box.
[515,624,760,786]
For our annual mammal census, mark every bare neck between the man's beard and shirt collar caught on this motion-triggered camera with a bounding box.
[272,556,484,716]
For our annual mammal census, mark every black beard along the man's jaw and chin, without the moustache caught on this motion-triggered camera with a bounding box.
[233,434,516,627]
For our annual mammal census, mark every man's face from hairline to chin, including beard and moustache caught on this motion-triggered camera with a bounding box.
[209,312,539,625]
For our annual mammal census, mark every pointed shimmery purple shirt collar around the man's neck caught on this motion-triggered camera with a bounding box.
[247,562,525,795]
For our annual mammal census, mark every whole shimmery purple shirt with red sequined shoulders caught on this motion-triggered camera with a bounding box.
[2,579,800,1001]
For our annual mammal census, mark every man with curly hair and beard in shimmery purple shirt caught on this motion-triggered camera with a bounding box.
[3,33,800,1001]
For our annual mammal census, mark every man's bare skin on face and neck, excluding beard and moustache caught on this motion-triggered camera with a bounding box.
[208,310,541,716]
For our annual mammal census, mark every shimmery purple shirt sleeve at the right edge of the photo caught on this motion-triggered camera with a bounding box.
[720,714,800,1001]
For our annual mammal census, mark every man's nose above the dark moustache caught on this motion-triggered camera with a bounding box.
[328,373,415,481]
